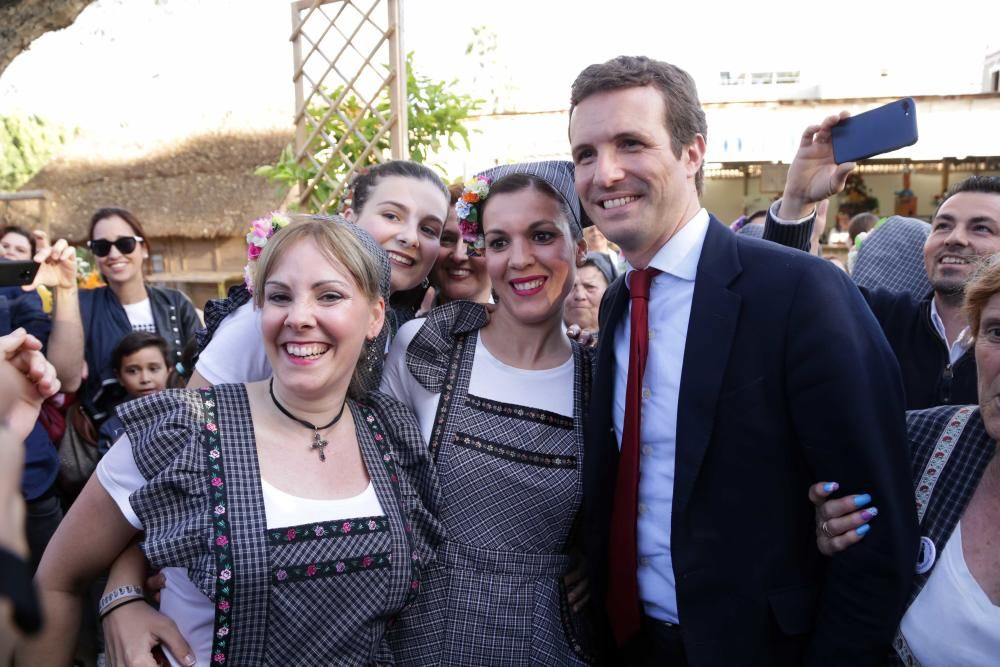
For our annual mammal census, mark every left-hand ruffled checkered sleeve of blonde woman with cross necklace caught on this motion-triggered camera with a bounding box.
[118,389,219,597]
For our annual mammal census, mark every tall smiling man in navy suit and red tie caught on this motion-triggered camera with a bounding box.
[569,57,917,667]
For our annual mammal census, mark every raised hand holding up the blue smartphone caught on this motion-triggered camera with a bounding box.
[778,111,855,220]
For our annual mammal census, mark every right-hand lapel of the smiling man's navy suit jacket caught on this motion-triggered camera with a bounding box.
[673,217,742,517]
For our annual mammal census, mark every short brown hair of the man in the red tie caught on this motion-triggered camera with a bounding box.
[569,56,708,195]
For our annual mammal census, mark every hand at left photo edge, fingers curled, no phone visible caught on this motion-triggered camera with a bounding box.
[0,329,59,441]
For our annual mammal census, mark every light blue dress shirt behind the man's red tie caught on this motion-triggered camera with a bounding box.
[613,209,709,623]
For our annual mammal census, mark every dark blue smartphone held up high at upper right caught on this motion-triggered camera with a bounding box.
[832,97,917,164]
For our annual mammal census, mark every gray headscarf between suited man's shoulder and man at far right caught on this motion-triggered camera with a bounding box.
[851,215,931,299]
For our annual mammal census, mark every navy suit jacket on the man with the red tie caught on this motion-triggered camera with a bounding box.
[583,218,917,667]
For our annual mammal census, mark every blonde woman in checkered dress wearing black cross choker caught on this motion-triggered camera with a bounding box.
[25,219,442,665]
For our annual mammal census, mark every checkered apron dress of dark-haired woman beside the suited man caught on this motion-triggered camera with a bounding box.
[389,306,590,667]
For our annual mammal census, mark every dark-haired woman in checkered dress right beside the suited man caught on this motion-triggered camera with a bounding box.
[382,162,591,667]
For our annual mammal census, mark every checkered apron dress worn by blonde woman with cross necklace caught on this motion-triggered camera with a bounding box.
[123,385,433,665]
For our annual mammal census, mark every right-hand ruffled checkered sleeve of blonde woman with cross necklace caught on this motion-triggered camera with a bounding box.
[363,391,444,564]
